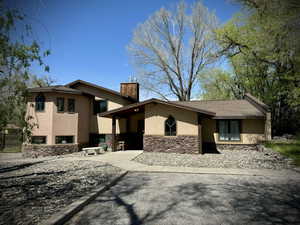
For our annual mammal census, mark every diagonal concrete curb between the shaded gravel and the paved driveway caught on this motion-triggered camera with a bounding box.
[40,171,128,225]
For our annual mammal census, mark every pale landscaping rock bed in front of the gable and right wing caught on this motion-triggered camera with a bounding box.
[134,146,293,169]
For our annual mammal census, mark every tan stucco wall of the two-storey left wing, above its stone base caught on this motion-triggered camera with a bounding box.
[26,93,90,145]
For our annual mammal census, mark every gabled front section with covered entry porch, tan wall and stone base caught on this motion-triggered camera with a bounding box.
[101,99,214,154]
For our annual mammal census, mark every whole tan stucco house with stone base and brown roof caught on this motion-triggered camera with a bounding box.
[23,80,271,156]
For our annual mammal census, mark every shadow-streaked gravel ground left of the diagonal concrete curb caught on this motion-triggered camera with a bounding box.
[0,157,122,225]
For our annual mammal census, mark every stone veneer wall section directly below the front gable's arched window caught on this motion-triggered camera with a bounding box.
[144,135,199,154]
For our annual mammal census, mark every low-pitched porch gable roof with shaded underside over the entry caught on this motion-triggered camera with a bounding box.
[100,98,216,118]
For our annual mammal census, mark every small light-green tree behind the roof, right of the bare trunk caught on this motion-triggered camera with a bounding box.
[199,68,239,100]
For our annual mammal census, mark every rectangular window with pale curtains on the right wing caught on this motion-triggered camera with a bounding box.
[219,120,241,141]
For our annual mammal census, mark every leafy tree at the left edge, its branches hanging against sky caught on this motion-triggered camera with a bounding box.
[0,0,50,132]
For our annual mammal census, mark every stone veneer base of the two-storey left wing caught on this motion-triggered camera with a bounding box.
[22,144,87,158]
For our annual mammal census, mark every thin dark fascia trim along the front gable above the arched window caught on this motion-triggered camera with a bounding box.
[100,98,216,117]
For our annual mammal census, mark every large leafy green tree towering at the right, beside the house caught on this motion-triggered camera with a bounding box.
[216,0,300,135]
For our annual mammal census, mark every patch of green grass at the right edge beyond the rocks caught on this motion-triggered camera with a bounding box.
[265,140,300,166]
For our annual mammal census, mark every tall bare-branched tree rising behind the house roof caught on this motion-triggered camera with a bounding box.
[128,1,217,101]
